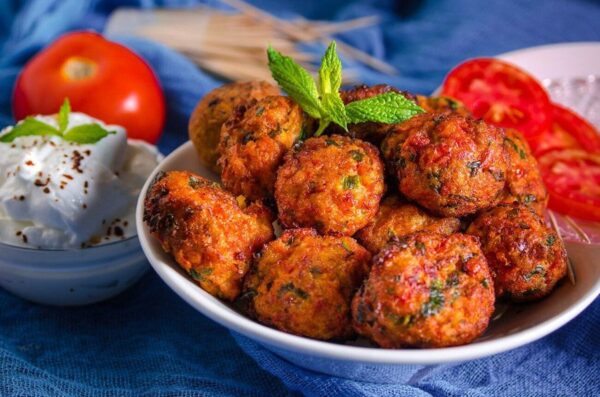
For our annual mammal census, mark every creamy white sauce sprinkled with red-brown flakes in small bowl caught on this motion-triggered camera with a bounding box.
[0,113,161,249]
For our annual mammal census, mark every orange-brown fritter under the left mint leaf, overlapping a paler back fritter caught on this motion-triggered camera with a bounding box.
[218,96,307,200]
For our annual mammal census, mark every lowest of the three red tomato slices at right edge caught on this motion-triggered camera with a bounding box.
[538,149,600,221]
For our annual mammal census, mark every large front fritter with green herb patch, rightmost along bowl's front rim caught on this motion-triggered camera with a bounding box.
[352,232,494,348]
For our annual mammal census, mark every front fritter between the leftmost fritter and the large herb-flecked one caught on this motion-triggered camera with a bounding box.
[244,229,371,340]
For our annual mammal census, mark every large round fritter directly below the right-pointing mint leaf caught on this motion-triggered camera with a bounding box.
[381,113,507,217]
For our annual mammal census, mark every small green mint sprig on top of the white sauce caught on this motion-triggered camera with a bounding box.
[0,98,115,144]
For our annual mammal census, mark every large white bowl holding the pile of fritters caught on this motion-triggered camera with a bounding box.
[136,142,600,382]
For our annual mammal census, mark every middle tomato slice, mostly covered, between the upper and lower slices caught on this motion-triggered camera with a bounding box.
[530,104,600,156]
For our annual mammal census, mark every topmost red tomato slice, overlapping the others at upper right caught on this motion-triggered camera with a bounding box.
[442,58,551,138]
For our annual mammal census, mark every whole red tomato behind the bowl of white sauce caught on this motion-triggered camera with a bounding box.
[13,32,165,143]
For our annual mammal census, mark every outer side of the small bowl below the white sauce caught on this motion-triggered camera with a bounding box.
[0,236,149,306]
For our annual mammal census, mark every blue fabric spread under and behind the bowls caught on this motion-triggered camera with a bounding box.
[0,0,600,396]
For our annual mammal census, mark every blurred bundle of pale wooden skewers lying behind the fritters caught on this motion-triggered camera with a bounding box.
[128,0,386,83]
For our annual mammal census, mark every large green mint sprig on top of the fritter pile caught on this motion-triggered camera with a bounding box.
[267,41,425,136]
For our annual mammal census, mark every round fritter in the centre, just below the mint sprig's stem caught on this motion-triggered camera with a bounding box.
[275,135,385,236]
